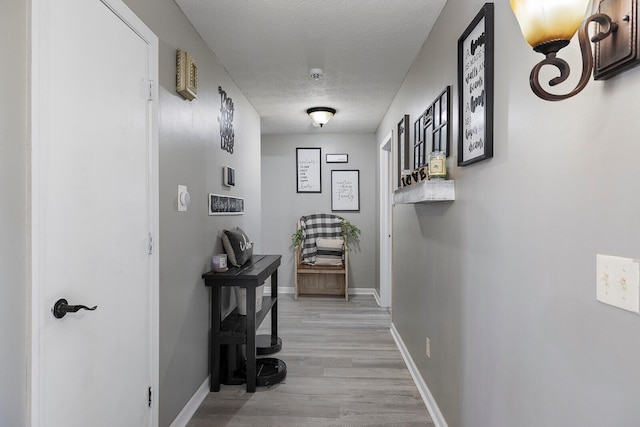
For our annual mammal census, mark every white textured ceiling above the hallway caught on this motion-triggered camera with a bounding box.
[176,0,446,134]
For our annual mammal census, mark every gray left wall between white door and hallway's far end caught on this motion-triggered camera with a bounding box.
[122,0,261,426]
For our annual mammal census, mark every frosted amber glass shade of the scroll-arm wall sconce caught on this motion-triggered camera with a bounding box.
[510,0,591,48]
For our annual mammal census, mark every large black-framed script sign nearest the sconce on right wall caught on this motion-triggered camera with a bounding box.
[458,3,494,166]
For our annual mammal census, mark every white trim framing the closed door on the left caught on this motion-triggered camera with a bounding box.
[26,0,160,427]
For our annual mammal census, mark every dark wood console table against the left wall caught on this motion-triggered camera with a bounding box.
[202,255,282,392]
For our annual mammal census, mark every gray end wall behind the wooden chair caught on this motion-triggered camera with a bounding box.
[262,134,379,291]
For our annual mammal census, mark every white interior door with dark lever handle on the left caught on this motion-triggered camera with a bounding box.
[31,0,158,427]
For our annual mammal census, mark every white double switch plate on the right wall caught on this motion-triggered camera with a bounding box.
[596,254,640,313]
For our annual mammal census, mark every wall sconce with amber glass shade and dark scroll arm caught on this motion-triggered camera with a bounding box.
[510,0,640,101]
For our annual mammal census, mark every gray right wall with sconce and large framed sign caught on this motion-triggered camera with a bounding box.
[377,0,640,427]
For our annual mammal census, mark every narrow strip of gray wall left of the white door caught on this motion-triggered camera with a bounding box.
[0,0,29,426]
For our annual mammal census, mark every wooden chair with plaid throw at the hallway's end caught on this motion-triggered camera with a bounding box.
[294,214,349,301]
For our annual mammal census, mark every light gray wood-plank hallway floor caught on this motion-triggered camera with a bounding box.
[188,295,434,427]
